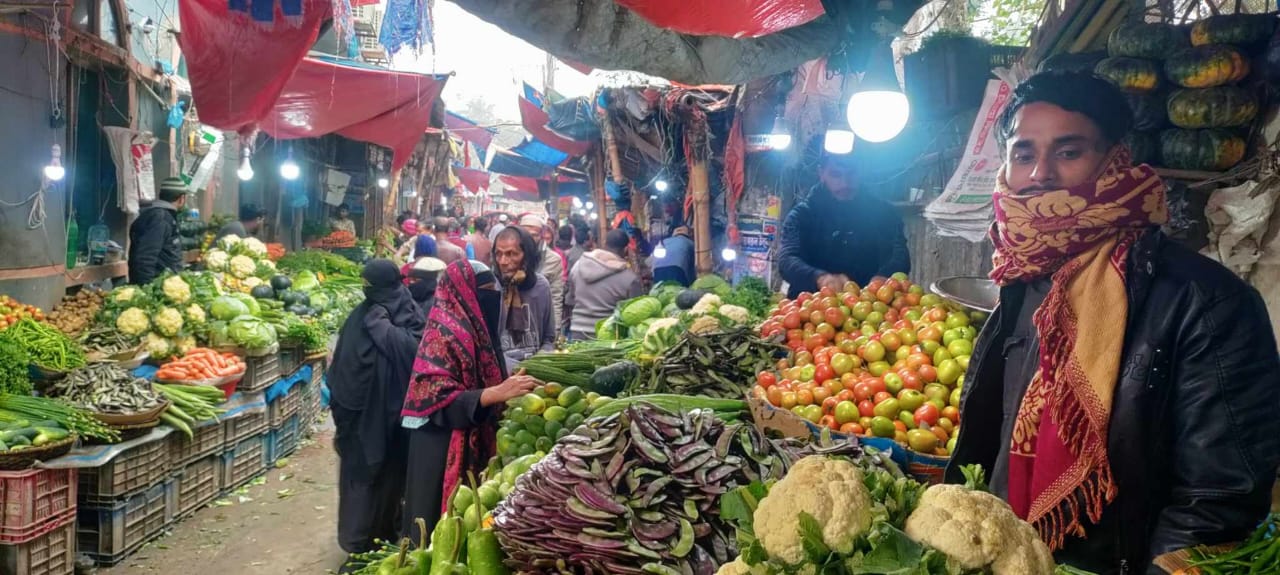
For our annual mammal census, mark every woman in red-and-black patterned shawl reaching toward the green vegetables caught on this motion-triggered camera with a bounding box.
[401,259,538,540]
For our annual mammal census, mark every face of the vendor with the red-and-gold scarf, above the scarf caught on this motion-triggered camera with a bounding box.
[1005,102,1111,193]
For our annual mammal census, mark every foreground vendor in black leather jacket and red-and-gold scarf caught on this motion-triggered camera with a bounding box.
[947,73,1280,574]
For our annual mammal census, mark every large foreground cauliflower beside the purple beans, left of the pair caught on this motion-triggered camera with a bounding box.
[753,456,874,565]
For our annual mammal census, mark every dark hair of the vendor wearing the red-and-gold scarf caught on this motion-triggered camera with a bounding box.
[996,70,1133,149]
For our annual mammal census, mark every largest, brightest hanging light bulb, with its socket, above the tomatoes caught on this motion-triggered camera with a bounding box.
[845,42,911,142]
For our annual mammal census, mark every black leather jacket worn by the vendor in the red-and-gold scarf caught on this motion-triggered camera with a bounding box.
[946,231,1280,574]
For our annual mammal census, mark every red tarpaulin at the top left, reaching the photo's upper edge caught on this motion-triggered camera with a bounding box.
[178,0,333,132]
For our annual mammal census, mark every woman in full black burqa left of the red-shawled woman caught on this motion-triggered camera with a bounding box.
[328,260,426,553]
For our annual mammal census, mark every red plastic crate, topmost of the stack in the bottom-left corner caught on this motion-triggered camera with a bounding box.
[0,469,77,544]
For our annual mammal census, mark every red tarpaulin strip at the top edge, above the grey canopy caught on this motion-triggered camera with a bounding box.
[614,0,824,38]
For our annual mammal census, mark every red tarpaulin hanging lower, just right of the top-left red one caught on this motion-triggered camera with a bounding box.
[260,58,447,169]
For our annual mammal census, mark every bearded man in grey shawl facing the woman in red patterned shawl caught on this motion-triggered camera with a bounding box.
[493,225,556,370]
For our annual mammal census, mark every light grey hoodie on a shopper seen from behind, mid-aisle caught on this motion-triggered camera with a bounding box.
[564,250,644,339]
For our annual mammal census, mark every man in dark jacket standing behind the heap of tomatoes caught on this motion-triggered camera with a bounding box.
[778,154,911,298]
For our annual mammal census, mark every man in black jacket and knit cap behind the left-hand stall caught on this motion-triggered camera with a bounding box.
[129,178,187,281]
